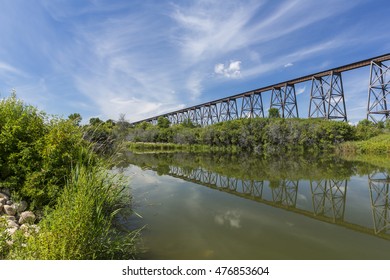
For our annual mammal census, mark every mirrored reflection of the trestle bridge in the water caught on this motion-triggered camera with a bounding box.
[169,165,390,240]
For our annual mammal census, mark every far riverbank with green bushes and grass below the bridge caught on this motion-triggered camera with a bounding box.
[127,118,390,155]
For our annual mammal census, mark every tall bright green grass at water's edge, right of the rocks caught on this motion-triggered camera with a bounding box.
[9,152,138,260]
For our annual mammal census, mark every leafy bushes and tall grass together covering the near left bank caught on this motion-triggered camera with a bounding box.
[0,94,138,259]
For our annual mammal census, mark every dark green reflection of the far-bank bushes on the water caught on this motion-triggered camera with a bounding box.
[123,153,382,182]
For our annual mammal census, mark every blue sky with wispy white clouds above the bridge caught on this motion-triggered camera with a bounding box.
[0,0,390,122]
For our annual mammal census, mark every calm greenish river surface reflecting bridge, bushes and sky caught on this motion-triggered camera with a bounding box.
[119,154,390,259]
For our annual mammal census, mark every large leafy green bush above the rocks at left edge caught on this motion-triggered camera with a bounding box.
[0,95,86,208]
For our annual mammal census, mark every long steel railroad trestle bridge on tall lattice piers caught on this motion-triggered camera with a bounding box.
[133,53,390,126]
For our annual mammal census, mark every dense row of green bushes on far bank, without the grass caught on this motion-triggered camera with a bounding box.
[129,118,356,153]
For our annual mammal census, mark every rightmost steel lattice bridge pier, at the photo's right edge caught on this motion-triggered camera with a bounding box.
[367,61,390,123]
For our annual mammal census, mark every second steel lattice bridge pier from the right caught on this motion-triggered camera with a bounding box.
[309,71,347,121]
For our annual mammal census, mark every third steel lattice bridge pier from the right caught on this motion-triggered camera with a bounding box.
[270,84,299,118]
